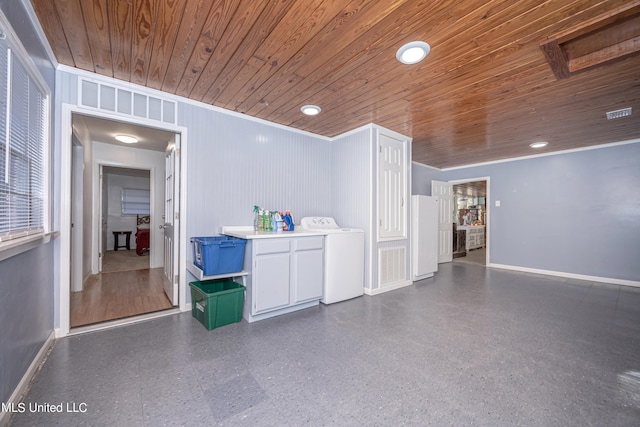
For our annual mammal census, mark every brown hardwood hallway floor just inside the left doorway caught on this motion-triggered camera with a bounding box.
[71,268,172,328]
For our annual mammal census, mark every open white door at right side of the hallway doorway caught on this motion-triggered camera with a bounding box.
[163,134,180,306]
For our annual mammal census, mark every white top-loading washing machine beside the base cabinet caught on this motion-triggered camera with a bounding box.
[300,217,364,304]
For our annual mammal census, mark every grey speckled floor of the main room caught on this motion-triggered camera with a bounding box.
[6,263,640,426]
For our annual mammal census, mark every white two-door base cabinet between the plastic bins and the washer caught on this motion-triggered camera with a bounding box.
[244,236,324,322]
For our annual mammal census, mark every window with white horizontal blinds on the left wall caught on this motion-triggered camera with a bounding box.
[0,27,48,242]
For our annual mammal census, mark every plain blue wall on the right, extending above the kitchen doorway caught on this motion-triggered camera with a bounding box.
[413,143,640,281]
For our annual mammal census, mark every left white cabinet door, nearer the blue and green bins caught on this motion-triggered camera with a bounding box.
[252,252,291,314]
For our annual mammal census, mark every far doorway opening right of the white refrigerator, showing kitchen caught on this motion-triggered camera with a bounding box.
[452,178,489,266]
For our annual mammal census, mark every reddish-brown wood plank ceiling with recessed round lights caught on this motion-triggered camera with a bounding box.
[32,0,640,168]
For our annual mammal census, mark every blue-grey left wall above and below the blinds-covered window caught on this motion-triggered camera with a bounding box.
[0,0,55,408]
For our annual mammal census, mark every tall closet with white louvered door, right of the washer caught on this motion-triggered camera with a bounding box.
[331,124,412,295]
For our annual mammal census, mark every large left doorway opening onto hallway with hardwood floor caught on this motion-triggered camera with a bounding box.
[68,113,180,330]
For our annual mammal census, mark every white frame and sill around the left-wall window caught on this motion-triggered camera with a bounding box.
[0,11,52,260]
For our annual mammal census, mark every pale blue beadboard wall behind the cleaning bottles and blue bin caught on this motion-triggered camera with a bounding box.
[178,103,332,257]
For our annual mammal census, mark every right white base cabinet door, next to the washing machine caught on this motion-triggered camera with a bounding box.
[292,249,324,303]
